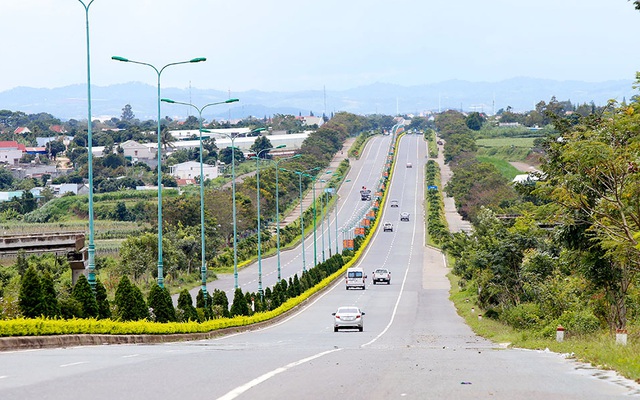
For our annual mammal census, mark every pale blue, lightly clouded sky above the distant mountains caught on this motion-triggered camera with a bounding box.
[0,0,640,94]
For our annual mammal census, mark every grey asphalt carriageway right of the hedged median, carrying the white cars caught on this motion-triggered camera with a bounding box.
[0,135,640,400]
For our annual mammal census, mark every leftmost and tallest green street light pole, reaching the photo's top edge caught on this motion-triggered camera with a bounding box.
[78,0,96,294]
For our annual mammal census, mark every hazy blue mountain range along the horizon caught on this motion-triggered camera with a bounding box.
[0,78,638,120]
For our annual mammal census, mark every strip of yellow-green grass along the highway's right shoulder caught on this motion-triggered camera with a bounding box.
[448,273,640,383]
